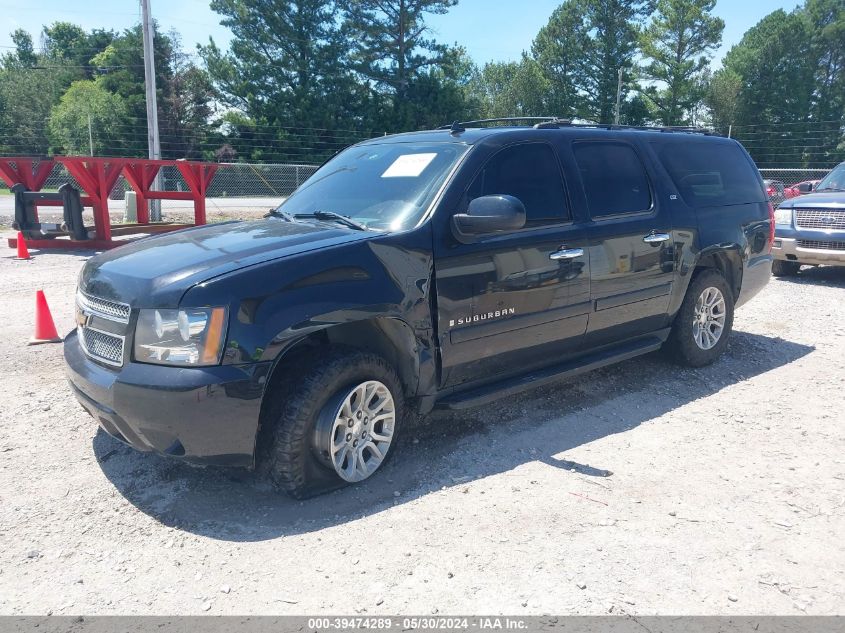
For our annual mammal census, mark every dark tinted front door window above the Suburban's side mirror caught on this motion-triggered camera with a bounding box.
[466,143,570,226]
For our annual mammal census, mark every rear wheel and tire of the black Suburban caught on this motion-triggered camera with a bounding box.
[666,269,734,367]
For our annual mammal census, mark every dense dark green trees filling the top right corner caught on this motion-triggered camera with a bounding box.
[724,0,845,167]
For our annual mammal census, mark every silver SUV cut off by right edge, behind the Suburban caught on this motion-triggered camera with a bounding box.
[772,163,845,277]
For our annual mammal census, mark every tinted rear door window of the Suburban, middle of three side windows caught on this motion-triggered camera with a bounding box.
[572,141,651,218]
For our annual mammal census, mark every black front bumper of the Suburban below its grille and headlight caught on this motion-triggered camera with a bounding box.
[64,332,271,466]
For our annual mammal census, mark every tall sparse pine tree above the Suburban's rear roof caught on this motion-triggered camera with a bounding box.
[640,0,725,125]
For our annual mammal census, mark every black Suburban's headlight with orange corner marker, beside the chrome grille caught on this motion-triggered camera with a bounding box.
[135,308,226,366]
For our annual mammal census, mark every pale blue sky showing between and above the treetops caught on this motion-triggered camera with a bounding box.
[0,0,800,66]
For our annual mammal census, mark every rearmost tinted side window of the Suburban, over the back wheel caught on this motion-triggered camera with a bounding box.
[653,141,766,207]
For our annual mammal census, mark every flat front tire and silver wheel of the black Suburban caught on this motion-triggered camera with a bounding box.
[260,348,405,499]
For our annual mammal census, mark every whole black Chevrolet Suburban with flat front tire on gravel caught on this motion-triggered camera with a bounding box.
[64,119,774,497]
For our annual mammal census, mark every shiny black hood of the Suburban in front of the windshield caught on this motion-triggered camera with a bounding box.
[79,218,373,308]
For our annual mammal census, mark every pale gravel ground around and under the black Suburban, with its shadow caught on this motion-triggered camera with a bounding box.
[0,235,845,615]
